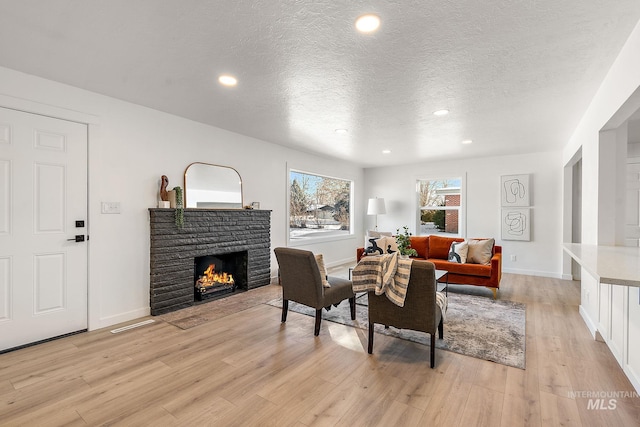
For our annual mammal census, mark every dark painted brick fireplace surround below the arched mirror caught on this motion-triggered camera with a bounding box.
[149,209,271,316]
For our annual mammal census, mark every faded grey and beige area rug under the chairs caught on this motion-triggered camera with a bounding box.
[267,292,526,369]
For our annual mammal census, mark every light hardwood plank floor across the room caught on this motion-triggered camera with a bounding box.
[0,274,640,427]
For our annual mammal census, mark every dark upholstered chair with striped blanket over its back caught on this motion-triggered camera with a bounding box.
[367,260,443,368]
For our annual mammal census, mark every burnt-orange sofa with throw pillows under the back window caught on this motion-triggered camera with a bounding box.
[356,235,502,299]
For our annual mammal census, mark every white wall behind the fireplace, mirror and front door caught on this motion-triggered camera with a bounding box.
[0,67,364,329]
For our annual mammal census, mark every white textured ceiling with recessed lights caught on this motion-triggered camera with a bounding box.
[0,0,640,167]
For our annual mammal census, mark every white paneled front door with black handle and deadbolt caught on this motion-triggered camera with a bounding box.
[0,108,88,351]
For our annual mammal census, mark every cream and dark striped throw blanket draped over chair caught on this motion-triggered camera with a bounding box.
[351,252,412,307]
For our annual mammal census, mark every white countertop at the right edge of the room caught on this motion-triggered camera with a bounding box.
[563,243,640,287]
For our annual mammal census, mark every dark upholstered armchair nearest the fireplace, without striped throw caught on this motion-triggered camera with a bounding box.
[273,248,356,336]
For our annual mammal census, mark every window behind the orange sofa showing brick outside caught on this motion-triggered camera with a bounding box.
[417,178,462,236]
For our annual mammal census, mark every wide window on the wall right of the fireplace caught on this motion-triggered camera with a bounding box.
[289,170,353,241]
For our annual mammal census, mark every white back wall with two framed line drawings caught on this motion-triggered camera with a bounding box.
[364,151,563,277]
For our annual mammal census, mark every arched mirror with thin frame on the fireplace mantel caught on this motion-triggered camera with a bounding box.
[184,163,242,209]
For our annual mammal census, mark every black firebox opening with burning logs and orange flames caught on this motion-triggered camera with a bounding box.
[194,251,247,301]
